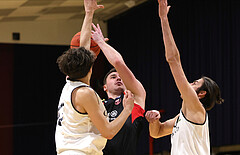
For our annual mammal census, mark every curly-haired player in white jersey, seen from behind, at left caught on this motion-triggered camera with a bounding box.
[55,0,134,155]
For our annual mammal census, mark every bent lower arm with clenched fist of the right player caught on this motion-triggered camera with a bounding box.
[145,110,179,138]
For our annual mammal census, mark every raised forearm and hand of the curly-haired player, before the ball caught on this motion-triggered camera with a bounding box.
[80,0,103,50]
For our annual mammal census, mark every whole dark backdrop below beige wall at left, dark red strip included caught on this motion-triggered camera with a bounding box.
[0,44,105,155]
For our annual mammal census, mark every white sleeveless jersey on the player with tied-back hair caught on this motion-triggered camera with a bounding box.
[171,111,210,155]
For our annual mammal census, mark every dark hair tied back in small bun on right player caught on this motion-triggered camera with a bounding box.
[197,76,224,110]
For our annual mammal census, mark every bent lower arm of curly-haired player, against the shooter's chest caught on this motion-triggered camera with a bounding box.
[73,88,134,139]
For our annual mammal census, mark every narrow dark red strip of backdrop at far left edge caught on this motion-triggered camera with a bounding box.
[0,45,13,155]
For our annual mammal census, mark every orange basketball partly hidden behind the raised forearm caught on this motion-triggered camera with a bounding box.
[70,32,100,56]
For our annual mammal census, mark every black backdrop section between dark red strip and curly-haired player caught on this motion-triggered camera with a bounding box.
[13,45,67,155]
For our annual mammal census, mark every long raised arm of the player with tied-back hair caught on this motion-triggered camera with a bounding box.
[158,0,204,112]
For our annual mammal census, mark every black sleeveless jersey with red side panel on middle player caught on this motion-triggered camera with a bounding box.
[103,94,145,155]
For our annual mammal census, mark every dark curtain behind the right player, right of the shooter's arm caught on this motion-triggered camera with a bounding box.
[108,0,240,154]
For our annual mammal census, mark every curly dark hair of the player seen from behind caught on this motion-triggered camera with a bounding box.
[57,47,95,79]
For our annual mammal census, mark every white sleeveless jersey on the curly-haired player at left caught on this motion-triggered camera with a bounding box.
[55,80,107,155]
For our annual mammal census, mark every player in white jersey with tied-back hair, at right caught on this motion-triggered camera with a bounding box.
[145,0,223,155]
